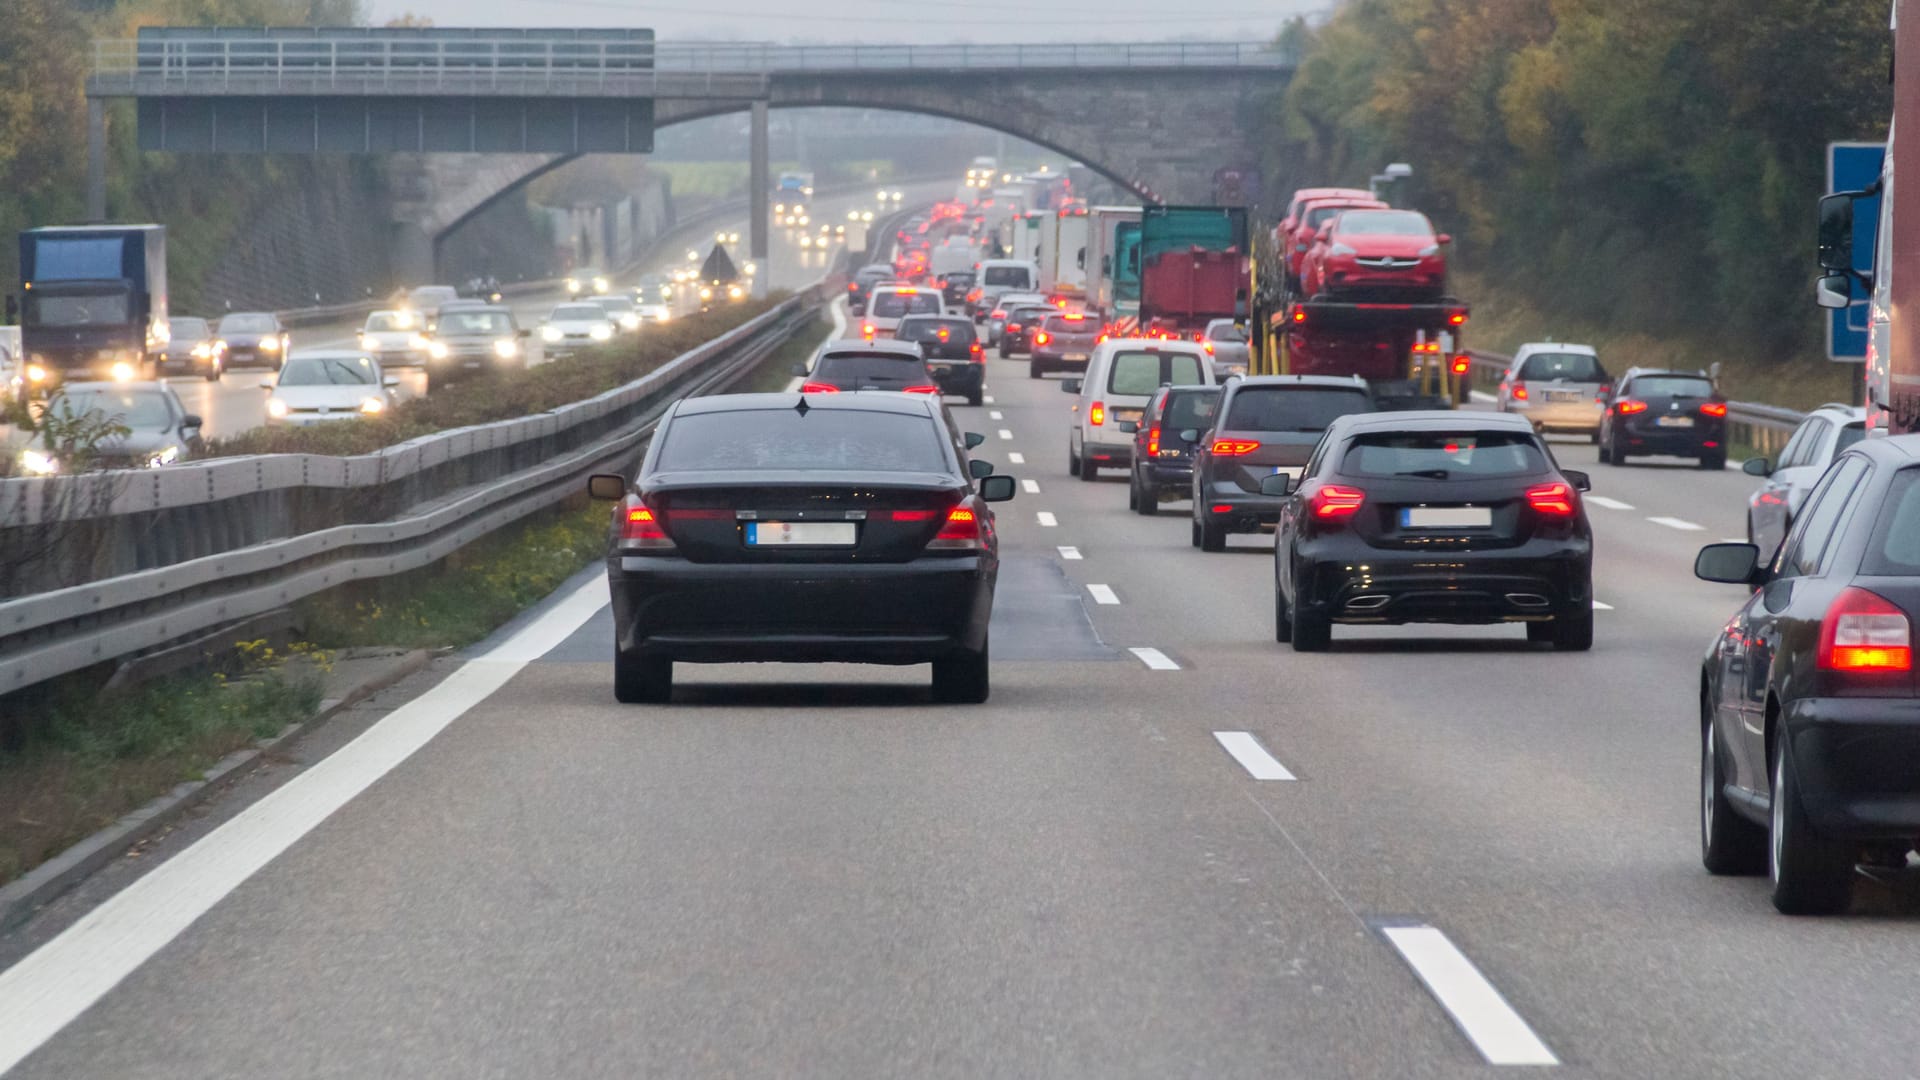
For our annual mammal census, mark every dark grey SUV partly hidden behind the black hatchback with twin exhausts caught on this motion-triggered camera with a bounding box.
[1192,375,1373,552]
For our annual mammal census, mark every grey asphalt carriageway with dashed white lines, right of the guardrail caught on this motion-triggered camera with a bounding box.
[0,320,1920,1078]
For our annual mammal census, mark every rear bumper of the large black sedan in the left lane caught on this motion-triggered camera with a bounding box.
[607,555,996,665]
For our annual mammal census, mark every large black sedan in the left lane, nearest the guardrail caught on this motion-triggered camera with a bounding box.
[589,394,1014,703]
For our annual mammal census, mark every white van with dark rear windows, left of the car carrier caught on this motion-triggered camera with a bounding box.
[1060,338,1215,480]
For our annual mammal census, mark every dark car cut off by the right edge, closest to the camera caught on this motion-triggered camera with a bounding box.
[1693,436,1920,915]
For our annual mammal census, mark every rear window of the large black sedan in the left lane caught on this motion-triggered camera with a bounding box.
[655,409,950,473]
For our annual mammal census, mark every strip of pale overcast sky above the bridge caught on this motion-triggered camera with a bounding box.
[367,0,1334,44]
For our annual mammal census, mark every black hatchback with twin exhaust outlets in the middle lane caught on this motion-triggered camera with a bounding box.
[1261,411,1594,651]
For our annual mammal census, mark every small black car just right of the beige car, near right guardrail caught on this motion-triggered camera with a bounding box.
[1599,367,1726,469]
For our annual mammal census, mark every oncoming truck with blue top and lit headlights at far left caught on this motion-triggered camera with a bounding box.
[8,225,169,396]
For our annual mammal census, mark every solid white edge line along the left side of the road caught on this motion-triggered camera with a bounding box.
[0,577,607,1072]
